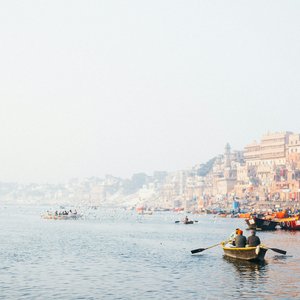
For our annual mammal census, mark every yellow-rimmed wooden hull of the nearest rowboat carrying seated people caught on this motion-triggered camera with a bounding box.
[222,246,268,261]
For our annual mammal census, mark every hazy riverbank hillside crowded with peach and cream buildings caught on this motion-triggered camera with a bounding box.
[0,132,300,211]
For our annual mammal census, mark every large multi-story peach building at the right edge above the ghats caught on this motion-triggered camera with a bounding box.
[241,132,300,204]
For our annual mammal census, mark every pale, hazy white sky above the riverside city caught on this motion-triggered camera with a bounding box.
[0,0,300,182]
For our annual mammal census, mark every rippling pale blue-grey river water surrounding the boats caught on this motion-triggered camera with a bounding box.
[0,206,300,299]
